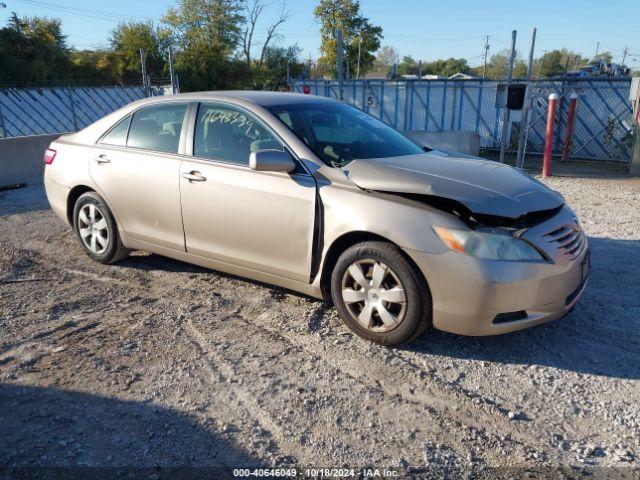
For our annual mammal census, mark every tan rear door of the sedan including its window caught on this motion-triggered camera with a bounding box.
[89,102,187,250]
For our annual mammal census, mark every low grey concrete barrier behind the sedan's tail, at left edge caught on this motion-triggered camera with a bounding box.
[0,133,61,187]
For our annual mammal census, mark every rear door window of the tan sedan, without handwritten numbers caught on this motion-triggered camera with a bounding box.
[127,103,187,153]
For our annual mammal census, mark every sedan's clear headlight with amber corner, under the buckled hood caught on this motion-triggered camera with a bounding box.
[433,227,544,262]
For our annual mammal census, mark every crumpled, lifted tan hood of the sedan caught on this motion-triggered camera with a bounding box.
[343,151,564,219]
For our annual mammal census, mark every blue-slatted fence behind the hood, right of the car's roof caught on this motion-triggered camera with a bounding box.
[293,78,633,162]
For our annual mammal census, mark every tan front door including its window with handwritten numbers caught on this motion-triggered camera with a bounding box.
[180,104,316,283]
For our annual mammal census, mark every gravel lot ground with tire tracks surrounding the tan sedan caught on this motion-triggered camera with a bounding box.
[0,178,640,478]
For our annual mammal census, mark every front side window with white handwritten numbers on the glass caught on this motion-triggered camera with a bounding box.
[193,103,284,165]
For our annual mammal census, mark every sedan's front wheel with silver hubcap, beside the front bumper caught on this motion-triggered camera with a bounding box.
[331,241,431,345]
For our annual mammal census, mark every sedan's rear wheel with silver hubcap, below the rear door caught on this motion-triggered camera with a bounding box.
[73,192,130,264]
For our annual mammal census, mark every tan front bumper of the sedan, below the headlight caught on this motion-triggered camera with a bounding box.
[405,246,589,336]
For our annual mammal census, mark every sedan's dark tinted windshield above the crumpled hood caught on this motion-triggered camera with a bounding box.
[267,102,424,167]
